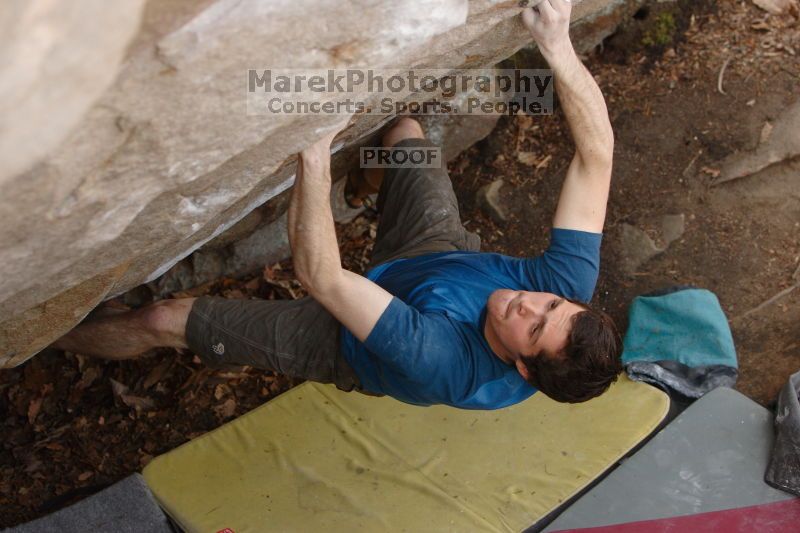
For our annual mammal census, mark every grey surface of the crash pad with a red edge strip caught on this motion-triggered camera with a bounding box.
[545,388,793,531]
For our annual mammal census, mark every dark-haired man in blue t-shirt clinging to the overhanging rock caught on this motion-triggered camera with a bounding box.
[56,0,621,409]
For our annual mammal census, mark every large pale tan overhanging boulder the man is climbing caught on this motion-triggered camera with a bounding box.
[0,0,640,366]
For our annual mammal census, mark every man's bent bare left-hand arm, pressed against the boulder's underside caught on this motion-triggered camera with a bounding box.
[288,124,392,342]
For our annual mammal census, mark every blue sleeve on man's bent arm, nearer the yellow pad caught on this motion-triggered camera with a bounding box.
[364,297,468,388]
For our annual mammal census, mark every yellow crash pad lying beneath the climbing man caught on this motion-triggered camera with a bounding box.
[144,378,669,533]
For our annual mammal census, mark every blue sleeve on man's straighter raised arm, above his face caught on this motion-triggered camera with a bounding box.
[528,228,603,302]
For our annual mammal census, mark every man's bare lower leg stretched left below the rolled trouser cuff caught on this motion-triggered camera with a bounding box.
[53,298,195,359]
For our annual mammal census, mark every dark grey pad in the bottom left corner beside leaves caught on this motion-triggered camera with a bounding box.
[3,474,174,533]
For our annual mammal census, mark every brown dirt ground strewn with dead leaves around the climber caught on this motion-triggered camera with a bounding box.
[0,1,800,527]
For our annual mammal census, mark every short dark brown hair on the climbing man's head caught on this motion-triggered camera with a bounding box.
[522,300,622,403]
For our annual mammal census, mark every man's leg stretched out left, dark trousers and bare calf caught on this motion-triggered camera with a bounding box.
[53,297,359,391]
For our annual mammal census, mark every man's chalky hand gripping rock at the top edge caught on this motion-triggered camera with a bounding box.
[522,0,572,61]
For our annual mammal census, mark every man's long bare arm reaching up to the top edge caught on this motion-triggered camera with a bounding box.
[523,0,614,233]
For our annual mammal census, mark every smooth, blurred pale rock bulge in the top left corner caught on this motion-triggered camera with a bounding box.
[0,0,144,186]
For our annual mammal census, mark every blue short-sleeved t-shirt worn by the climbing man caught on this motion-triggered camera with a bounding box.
[341,228,602,409]
